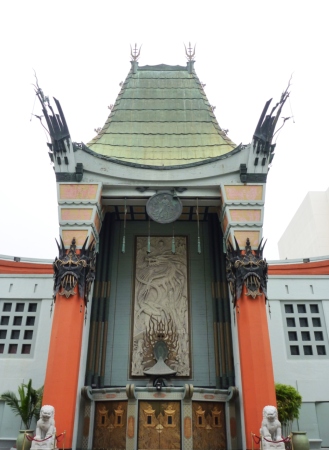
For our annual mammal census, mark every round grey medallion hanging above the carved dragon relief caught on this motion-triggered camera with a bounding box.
[146,192,183,223]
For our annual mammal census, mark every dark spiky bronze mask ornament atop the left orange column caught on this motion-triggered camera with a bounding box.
[53,238,96,304]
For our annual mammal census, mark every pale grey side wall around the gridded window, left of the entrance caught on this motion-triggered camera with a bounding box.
[0,275,53,449]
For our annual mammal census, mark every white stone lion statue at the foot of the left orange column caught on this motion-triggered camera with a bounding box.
[31,405,56,450]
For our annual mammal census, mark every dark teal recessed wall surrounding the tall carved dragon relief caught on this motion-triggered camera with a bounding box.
[105,222,215,386]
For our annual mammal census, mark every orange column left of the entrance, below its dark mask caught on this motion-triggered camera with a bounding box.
[42,287,85,449]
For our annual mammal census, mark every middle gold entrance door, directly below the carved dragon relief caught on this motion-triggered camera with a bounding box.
[138,401,181,450]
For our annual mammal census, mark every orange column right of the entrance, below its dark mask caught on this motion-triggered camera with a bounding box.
[236,286,276,450]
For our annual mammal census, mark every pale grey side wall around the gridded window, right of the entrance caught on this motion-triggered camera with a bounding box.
[268,275,329,447]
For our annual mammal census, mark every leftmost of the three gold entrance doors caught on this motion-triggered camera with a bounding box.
[93,402,127,450]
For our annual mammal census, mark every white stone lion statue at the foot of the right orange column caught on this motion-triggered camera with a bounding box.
[260,405,285,449]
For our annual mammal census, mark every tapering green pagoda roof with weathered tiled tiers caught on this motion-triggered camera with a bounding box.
[87,62,236,166]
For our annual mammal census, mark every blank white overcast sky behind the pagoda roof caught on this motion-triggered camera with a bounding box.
[0,0,329,260]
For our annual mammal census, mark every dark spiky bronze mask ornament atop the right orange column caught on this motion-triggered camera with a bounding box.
[226,239,268,306]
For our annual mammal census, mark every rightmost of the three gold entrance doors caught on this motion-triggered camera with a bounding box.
[192,402,227,450]
